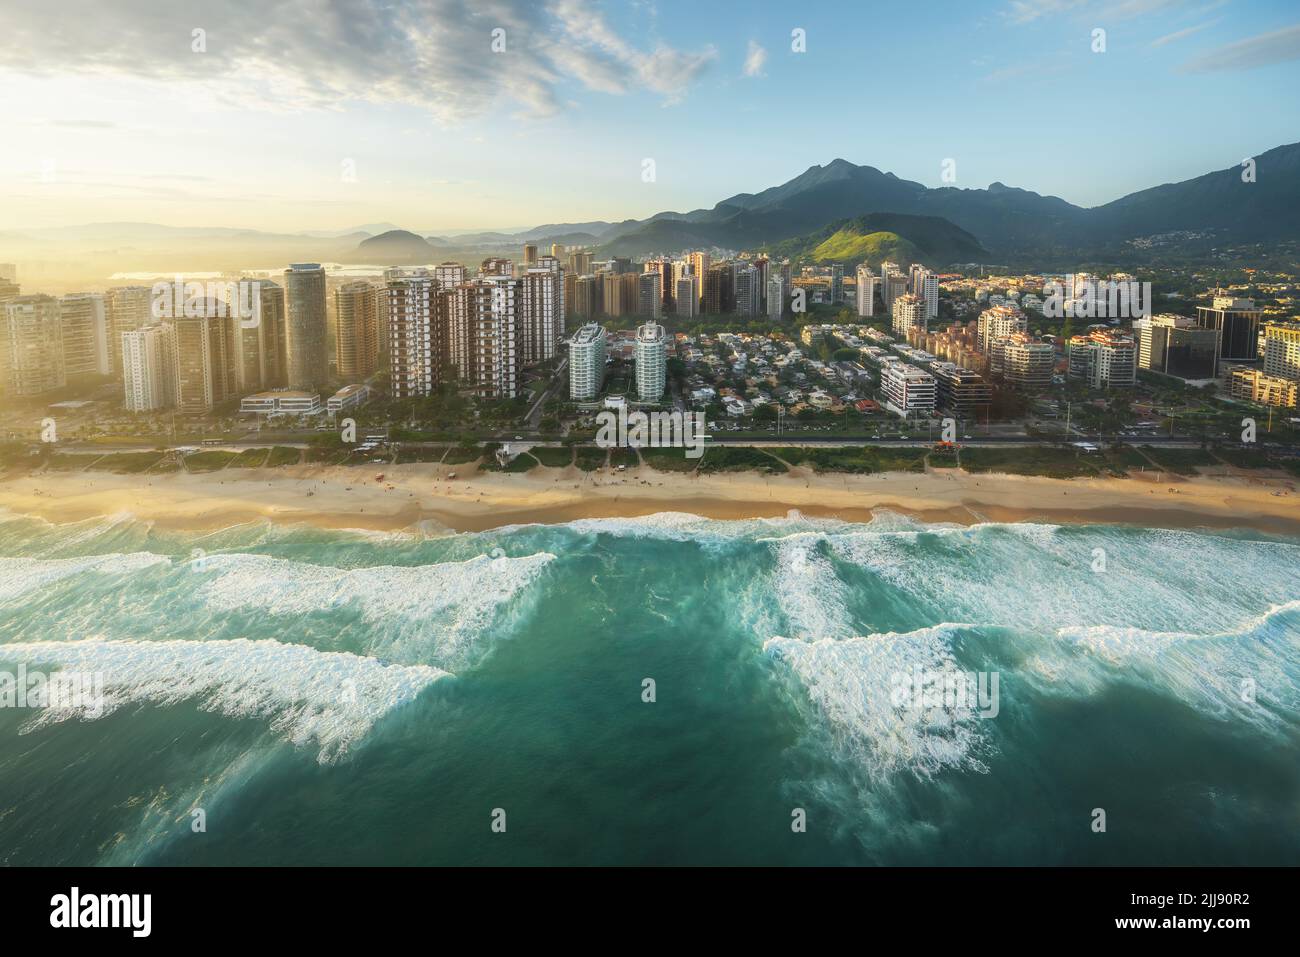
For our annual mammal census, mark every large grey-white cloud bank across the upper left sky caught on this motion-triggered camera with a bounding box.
[0,0,715,122]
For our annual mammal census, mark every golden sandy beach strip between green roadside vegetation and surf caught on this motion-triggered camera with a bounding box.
[0,464,1300,534]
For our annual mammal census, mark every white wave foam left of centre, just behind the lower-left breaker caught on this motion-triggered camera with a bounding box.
[199,551,555,659]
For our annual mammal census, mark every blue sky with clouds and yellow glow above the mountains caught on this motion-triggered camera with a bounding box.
[0,0,1300,233]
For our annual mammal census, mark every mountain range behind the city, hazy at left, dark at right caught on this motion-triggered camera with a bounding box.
[10,143,1300,280]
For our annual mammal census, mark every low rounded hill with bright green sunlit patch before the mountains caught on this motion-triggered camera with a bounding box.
[767,213,989,267]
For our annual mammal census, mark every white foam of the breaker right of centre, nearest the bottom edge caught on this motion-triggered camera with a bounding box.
[763,624,987,778]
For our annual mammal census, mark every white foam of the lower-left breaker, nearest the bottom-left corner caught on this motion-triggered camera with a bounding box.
[0,638,447,763]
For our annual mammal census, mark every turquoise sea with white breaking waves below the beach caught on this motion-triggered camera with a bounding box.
[0,514,1300,865]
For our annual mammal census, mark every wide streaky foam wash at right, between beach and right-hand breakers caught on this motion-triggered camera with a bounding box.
[828,524,1300,633]
